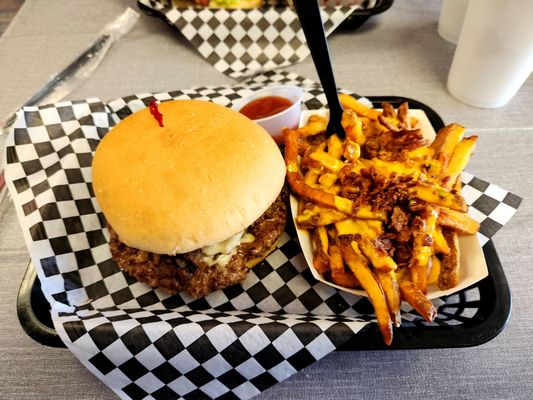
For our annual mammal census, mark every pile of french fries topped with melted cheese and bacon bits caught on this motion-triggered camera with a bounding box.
[283,94,479,345]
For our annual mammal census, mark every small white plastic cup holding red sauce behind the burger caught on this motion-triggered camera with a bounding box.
[231,85,304,144]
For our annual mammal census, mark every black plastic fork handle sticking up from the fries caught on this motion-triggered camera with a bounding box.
[293,0,343,134]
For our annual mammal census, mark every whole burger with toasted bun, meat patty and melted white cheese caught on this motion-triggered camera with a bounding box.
[92,100,287,297]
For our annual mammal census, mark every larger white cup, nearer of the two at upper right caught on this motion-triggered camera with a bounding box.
[448,0,533,108]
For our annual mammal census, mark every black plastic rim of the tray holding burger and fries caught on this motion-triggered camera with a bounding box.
[17,96,512,351]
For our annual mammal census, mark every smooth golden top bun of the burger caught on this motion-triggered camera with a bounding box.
[92,100,285,254]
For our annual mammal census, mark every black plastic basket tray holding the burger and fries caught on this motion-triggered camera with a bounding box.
[17,96,511,351]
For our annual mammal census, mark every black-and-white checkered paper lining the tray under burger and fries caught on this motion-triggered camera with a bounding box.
[6,73,520,399]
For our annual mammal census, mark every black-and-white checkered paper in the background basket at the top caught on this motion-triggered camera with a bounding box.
[138,0,371,78]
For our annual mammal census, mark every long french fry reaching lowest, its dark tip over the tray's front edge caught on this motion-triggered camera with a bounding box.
[341,239,392,345]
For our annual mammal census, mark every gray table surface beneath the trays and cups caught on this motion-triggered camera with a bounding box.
[0,0,533,399]
